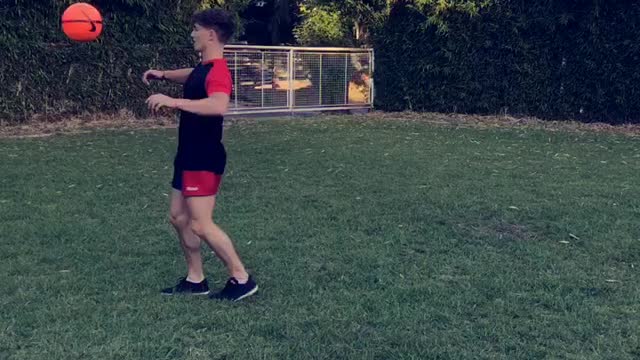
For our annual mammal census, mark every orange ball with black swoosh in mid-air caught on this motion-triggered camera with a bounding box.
[62,3,102,42]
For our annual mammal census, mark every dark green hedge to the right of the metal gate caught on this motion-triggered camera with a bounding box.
[373,0,640,123]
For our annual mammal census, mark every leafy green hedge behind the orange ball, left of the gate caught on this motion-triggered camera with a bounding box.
[0,0,218,122]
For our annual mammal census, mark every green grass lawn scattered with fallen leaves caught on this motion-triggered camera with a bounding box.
[0,118,640,360]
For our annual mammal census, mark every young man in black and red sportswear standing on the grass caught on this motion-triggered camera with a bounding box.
[143,9,258,301]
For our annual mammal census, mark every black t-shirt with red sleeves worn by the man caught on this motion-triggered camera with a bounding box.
[175,59,232,174]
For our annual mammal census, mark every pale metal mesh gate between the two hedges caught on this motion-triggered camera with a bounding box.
[224,45,374,115]
